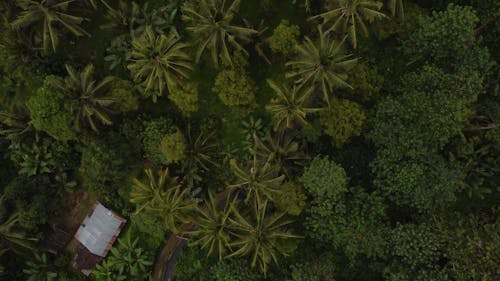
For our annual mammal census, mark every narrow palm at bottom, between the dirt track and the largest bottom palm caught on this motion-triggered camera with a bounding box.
[190,193,231,260]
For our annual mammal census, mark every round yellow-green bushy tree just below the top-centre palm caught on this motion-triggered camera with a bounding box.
[212,68,255,107]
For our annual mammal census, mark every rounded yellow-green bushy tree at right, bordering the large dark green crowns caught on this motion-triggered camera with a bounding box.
[320,98,366,147]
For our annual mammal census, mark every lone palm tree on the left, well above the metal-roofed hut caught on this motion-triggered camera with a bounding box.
[59,64,115,132]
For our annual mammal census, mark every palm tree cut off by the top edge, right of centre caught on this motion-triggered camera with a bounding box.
[309,0,386,49]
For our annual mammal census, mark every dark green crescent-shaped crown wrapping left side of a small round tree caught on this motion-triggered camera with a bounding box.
[140,118,176,164]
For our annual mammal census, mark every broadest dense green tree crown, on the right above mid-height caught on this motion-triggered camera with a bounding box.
[369,66,480,157]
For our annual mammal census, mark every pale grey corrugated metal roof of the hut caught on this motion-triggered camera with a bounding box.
[75,202,126,257]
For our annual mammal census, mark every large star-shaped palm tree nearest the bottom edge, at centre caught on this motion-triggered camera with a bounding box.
[227,200,300,273]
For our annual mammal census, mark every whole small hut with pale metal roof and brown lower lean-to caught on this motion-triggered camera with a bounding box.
[73,202,127,275]
